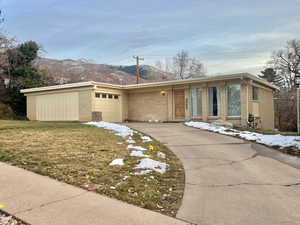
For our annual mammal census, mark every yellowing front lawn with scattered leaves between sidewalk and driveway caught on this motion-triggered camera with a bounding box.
[0,120,184,216]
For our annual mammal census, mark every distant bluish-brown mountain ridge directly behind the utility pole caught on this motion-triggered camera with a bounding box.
[109,65,175,81]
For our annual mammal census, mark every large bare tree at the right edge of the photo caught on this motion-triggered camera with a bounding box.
[269,39,300,89]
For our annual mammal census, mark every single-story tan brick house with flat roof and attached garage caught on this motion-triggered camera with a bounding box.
[21,73,277,129]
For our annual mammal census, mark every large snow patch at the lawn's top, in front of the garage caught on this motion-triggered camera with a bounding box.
[85,121,134,138]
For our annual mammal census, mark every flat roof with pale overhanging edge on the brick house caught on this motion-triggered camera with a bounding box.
[21,73,279,93]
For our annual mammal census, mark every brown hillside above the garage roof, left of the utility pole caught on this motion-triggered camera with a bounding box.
[33,58,146,84]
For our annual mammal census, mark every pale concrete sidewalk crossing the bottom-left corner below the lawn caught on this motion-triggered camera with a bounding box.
[0,163,189,225]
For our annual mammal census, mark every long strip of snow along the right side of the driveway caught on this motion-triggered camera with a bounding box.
[185,121,300,149]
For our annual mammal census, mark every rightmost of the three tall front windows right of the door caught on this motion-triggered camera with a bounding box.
[228,84,241,116]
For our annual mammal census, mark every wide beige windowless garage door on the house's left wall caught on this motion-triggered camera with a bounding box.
[36,92,79,121]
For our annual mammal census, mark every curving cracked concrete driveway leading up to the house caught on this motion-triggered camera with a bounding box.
[126,123,300,225]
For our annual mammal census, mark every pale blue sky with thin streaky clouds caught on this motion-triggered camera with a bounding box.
[0,0,300,75]
